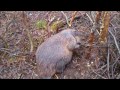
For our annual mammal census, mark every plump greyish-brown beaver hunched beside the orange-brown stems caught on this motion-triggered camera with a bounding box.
[35,29,81,79]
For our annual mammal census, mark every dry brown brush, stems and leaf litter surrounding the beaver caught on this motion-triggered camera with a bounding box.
[0,11,120,79]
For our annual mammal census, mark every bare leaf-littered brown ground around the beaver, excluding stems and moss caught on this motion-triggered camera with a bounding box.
[0,11,120,79]
